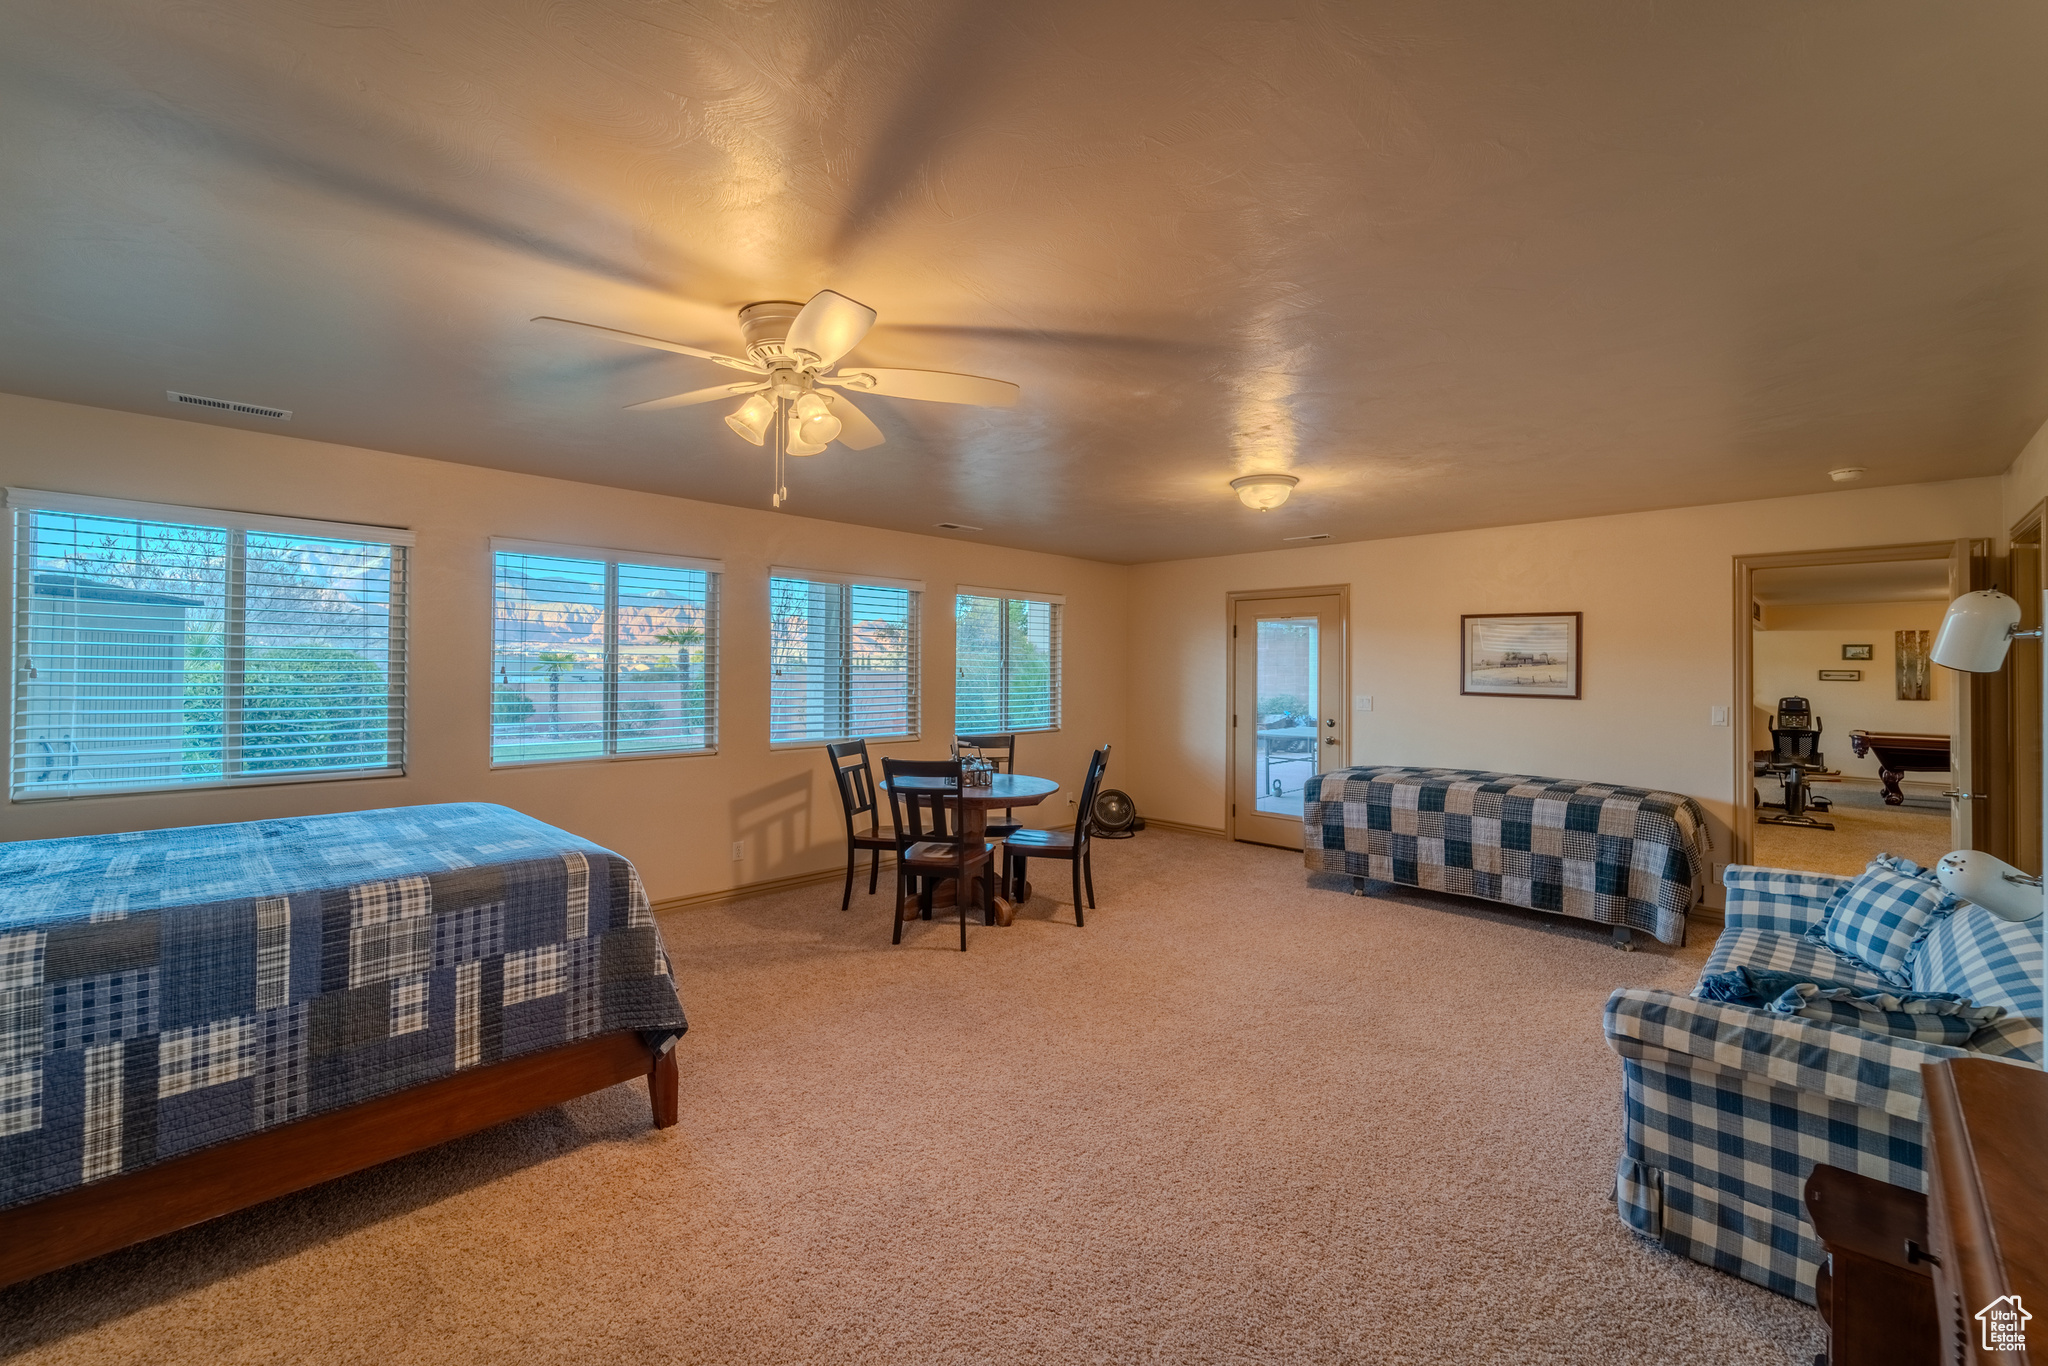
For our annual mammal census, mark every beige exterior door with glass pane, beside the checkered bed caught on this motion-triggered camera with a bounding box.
[1231,592,1348,850]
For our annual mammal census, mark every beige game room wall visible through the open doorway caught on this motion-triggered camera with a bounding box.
[1751,602,1956,786]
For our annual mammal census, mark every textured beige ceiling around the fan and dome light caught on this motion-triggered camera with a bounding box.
[0,0,2048,561]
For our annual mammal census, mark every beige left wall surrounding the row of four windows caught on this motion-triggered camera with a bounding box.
[0,395,1128,899]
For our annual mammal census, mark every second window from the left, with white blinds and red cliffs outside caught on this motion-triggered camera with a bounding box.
[492,541,723,764]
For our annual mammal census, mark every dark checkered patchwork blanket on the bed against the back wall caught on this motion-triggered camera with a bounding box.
[1303,766,1708,944]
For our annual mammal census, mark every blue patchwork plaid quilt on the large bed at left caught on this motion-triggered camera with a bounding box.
[0,803,686,1208]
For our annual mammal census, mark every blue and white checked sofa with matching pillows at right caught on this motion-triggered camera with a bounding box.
[1606,864,2042,1305]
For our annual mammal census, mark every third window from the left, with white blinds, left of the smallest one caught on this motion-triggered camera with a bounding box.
[768,569,924,743]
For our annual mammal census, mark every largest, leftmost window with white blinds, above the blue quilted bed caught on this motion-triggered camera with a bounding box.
[6,489,412,801]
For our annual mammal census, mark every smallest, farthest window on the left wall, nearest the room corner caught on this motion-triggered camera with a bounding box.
[952,588,1063,735]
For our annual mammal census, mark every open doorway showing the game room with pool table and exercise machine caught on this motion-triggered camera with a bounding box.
[1733,541,2011,874]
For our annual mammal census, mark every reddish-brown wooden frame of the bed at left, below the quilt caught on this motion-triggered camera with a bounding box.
[0,1030,680,1286]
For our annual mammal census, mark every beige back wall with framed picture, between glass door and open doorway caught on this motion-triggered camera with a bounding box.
[1128,477,2001,860]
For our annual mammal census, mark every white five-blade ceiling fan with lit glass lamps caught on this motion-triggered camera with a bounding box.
[532,289,1018,508]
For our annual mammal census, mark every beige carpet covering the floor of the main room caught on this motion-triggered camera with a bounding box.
[0,831,1819,1366]
